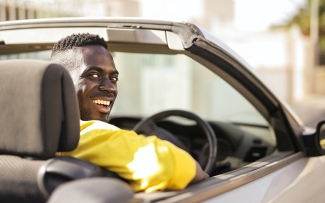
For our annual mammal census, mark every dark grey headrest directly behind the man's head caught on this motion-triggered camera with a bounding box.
[0,60,80,158]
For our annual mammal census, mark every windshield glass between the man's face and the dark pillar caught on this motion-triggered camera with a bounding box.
[112,53,267,125]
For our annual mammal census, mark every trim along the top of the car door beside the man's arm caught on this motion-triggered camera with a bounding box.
[151,152,304,203]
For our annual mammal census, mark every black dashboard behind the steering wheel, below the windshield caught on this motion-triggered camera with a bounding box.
[109,116,276,175]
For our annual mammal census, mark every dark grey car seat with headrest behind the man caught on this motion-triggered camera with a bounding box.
[0,60,80,203]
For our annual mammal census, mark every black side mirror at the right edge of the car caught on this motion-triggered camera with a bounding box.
[302,120,325,156]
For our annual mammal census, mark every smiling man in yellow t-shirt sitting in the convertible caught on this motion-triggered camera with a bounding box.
[51,34,208,192]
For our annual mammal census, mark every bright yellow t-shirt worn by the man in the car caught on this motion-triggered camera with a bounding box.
[57,120,196,192]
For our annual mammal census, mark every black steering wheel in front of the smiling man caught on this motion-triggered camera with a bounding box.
[133,110,217,174]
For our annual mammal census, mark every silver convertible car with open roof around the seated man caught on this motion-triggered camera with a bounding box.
[0,17,325,203]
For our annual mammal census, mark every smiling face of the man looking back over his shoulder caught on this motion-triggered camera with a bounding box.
[70,45,118,122]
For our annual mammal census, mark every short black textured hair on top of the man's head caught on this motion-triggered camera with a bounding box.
[52,33,107,56]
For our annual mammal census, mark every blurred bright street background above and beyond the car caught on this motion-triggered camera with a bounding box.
[0,0,325,127]
